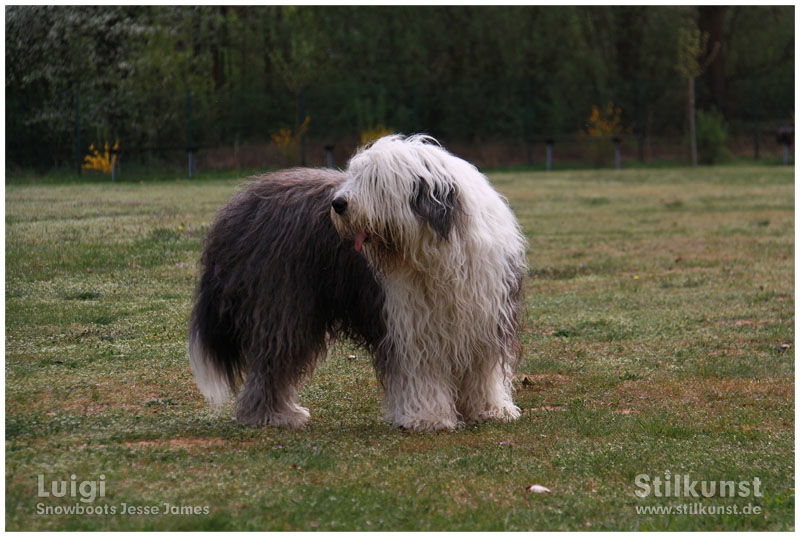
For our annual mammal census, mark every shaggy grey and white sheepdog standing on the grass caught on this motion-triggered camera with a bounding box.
[189,135,526,430]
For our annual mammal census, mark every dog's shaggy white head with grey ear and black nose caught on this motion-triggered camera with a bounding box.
[331,135,471,265]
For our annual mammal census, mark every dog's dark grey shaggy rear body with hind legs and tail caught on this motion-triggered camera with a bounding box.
[190,169,387,426]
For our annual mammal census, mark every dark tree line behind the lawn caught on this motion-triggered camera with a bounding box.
[6,6,794,167]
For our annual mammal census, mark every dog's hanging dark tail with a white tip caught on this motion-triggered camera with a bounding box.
[189,290,244,407]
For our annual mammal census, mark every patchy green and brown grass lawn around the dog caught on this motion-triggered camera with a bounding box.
[5,166,795,530]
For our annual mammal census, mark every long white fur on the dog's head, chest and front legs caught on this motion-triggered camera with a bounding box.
[335,135,526,430]
